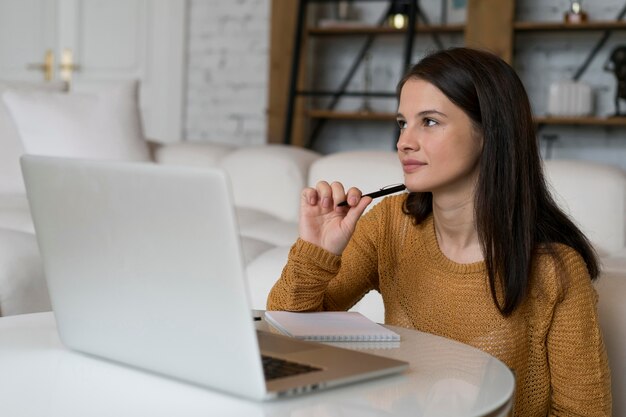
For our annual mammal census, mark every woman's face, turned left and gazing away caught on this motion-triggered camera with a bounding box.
[397,79,482,196]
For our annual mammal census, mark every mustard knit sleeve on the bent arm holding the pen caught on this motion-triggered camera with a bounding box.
[260,201,385,311]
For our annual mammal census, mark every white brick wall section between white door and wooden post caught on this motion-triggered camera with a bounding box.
[184,0,270,145]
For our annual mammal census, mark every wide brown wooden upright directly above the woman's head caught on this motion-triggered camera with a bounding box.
[465,0,515,64]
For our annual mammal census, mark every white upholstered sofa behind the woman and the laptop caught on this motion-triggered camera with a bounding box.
[7,142,626,314]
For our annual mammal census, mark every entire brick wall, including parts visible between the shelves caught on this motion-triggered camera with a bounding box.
[185,0,626,169]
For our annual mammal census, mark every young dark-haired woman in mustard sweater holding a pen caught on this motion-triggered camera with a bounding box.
[267,48,611,416]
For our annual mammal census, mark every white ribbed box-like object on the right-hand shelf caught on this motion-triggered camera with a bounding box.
[548,81,593,117]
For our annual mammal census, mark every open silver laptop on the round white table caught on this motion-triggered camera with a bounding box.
[21,156,407,399]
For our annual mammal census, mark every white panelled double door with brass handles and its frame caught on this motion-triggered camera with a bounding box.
[0,0,187,142]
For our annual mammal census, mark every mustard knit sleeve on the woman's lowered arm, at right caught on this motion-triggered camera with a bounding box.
[547,248,611,416]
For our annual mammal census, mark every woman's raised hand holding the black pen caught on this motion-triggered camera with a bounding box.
[299,181,372,255]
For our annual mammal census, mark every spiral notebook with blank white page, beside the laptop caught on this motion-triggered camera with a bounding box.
[265,311,400,342]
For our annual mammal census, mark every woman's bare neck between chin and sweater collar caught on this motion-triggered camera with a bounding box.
[433,195,483,264]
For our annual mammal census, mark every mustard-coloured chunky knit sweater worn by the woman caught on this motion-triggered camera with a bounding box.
[267,195,611,416]
